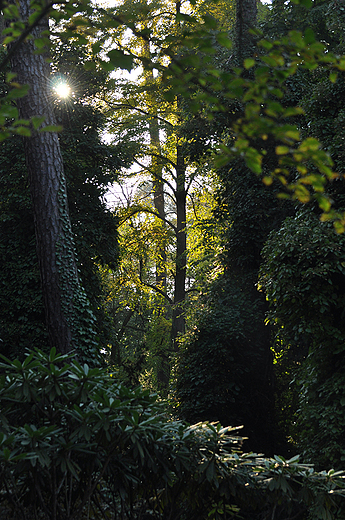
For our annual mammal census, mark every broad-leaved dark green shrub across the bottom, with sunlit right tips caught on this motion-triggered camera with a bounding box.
[0,349,345,520]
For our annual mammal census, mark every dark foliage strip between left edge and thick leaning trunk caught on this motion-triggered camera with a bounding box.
[0,138,48,357]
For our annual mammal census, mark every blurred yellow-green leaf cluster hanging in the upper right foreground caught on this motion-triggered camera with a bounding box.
[148,3,345,231]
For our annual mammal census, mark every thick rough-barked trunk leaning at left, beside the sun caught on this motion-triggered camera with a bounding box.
[11,0,91,353]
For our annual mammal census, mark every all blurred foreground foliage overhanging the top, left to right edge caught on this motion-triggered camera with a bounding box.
[5,1,345,225]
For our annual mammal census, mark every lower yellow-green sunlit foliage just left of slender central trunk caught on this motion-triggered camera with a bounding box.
[103,205,171,391]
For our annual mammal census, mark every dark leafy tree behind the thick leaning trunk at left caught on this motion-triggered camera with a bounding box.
[0,42,126,357]
